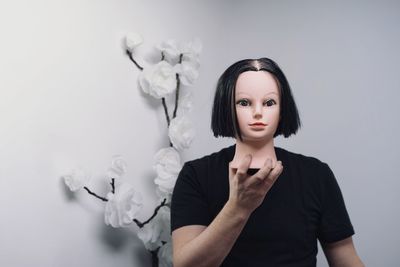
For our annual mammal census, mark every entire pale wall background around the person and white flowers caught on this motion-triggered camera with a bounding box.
[0,0,400,267]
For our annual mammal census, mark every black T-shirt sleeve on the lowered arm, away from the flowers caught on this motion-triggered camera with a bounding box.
[317,163,354,243]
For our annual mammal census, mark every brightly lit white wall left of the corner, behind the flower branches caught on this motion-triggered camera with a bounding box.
[0,0,225,267]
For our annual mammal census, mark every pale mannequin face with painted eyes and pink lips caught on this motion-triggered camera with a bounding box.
[235,71,280,142]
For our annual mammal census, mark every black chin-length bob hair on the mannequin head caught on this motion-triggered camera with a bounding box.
[211,58,301,140]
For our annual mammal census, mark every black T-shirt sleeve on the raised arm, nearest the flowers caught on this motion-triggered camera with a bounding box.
[171,163,210,232]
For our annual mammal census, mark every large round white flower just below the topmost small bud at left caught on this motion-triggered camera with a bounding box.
[139,61,177,98]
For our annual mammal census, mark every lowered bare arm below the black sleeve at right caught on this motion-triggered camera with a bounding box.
[321,237,365,267]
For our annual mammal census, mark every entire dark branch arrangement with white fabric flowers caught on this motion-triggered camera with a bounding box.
[63,33,202,267]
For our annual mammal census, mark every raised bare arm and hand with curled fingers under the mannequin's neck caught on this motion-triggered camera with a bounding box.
[172,157,283,267]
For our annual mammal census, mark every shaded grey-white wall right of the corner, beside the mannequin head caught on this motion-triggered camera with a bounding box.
[208,1,400,267]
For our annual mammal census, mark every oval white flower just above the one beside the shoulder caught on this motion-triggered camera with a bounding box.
[168,116,195,150]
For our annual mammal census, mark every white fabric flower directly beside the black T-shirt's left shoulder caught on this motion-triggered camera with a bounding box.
[154,147,182,194]
